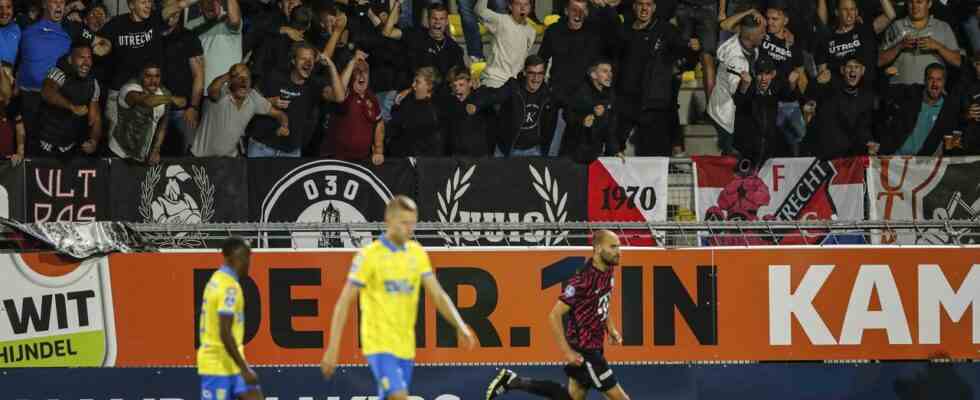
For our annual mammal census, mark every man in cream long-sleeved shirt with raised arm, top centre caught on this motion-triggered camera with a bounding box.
[476,0,532,88]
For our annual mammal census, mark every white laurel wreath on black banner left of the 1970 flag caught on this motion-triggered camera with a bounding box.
[436,165,568,246]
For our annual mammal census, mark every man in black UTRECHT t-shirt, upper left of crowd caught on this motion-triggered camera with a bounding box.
[92,0,196,139]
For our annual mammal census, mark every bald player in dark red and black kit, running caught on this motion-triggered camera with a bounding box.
[486,231,629,400]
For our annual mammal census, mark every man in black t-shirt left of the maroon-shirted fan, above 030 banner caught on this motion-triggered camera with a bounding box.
[246,42,346,158]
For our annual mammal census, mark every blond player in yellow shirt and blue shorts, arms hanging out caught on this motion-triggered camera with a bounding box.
[320,196,476,400]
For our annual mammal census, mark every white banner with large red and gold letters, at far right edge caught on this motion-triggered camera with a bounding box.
[868,157,980,244]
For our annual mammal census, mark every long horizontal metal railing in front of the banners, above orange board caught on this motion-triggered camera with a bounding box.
[115,220,980,248]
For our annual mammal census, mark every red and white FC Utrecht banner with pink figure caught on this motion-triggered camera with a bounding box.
[694,157,867,245]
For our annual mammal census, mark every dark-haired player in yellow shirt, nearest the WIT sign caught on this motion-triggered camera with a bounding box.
[197,237,262,400]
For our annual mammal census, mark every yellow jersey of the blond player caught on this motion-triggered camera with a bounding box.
[347,236,432,360]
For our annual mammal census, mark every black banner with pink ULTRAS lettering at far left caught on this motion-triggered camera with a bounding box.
[25,157,109,222]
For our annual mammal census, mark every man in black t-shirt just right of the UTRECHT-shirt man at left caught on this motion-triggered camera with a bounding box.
[162,9,204,157]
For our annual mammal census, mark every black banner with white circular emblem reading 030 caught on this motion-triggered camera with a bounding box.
[248,159,415,248]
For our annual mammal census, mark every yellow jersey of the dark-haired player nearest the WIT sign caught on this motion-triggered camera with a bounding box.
[197,266,245,376]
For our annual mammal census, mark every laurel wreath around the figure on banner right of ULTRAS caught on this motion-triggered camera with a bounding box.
[138,165,215,248]
